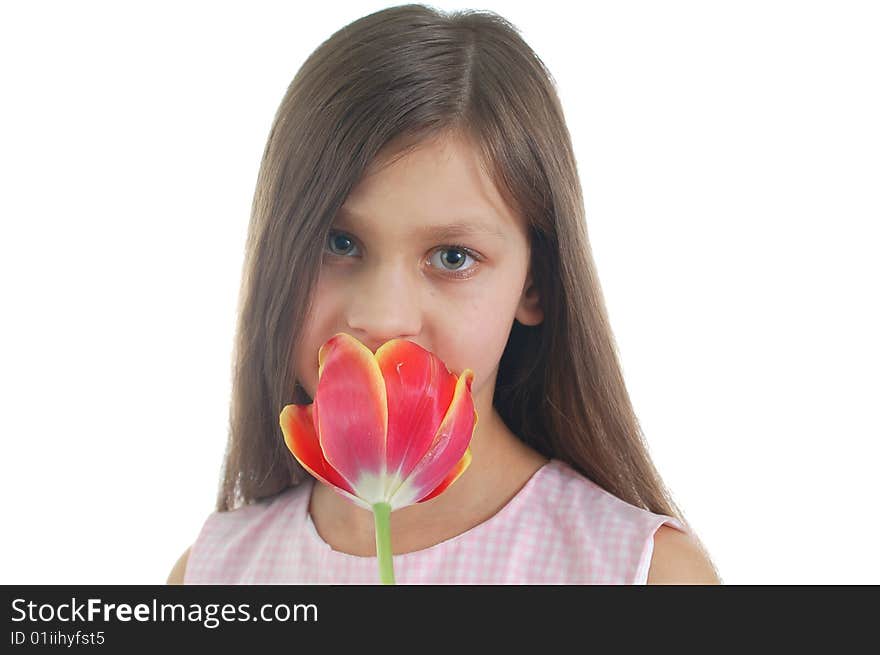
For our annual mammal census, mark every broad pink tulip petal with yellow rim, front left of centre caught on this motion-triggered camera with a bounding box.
[312,332,388,504]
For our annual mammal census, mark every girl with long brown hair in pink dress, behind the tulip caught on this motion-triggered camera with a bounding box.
[169,5,718,584]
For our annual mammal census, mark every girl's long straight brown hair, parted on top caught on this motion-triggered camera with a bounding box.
[217,5,720,576]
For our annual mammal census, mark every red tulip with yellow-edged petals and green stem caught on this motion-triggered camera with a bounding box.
[280,333,477,583]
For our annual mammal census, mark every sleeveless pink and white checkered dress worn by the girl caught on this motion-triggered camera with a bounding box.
[184,459,686,585]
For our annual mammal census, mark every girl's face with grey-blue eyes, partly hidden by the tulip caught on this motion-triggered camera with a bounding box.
[295,137,543,418]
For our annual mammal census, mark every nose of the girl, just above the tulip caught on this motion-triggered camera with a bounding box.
[346,263,422,352]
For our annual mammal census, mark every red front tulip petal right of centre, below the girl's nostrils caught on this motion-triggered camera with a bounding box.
[376,339,457,497]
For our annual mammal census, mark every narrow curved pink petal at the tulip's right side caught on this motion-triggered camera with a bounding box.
[390,369,477,510]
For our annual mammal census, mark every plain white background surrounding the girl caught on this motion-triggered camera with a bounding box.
[0,1,880,584]
